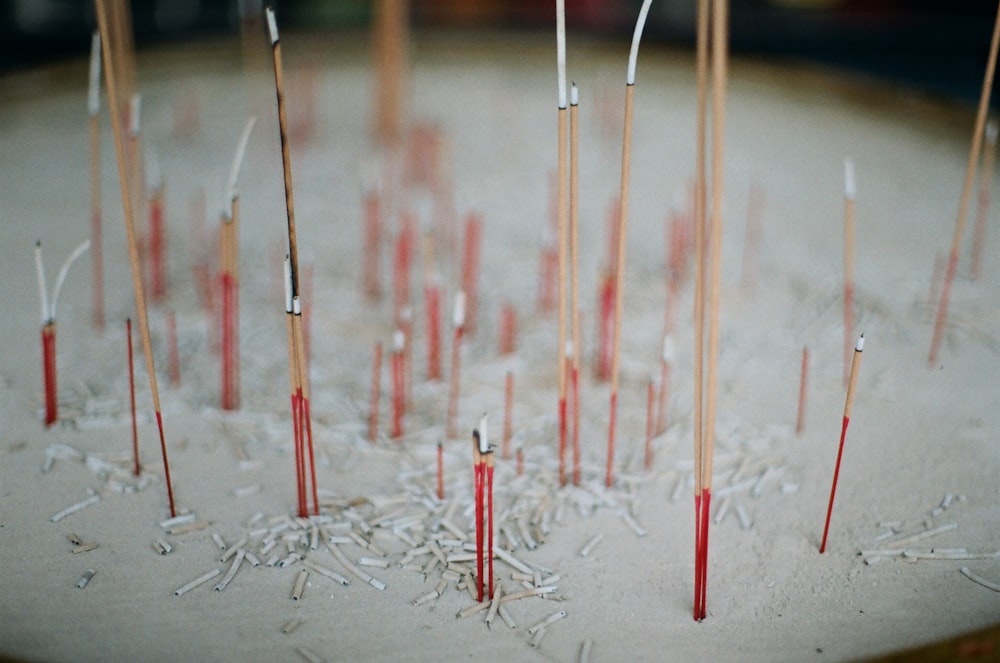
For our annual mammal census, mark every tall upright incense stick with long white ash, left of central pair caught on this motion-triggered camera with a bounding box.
[555,0,569,486]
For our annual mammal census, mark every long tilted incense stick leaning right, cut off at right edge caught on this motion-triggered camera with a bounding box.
[927,3,1000,367]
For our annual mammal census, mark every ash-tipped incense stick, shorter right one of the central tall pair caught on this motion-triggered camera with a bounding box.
[569,83,582,486]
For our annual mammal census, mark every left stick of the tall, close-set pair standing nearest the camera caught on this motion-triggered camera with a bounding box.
[694,0,710,620]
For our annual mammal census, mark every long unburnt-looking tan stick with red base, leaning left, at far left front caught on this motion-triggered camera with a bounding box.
[95,0,177,516]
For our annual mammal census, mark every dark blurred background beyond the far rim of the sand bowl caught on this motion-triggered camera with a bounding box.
[0,0,997,104]
